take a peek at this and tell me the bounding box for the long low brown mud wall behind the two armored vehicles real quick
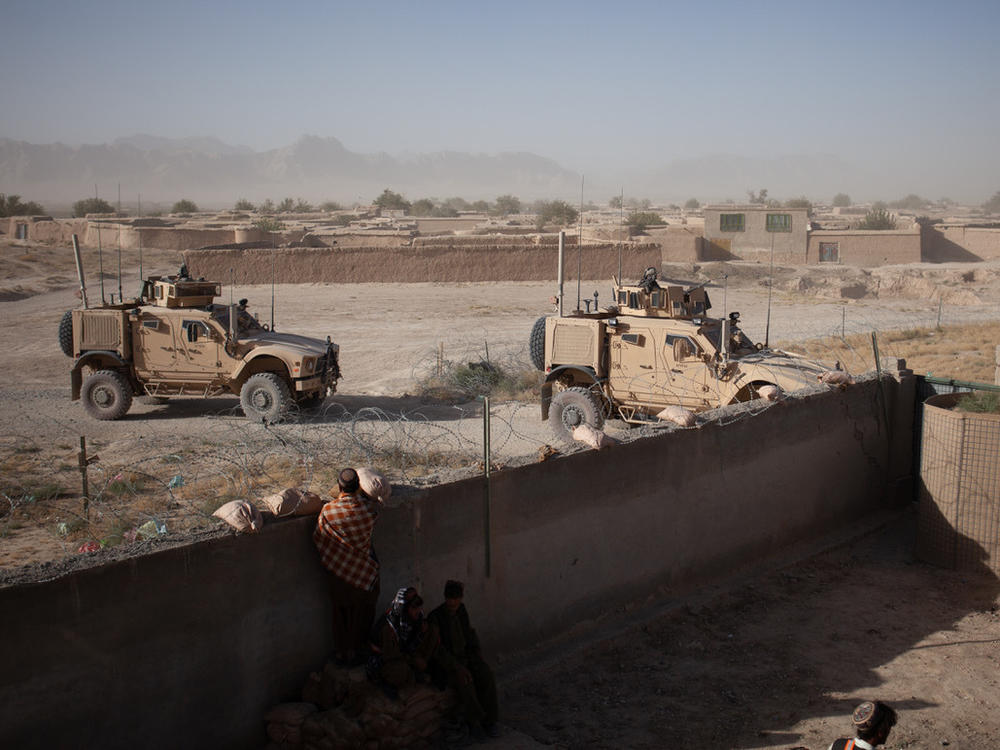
[184,244,660,284]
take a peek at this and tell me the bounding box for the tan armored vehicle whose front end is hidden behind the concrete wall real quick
[529,268,830,440]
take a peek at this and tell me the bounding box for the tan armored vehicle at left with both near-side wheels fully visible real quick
[59,269,340,422]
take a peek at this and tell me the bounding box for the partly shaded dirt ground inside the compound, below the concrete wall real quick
[502,510,1000,750]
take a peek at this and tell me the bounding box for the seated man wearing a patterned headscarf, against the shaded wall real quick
[367,586,438,691]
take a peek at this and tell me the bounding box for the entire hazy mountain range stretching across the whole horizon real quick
[0,135,984,209]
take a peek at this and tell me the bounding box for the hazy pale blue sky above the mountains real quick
[0,0,1000,197]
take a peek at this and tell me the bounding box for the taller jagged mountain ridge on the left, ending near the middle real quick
[0,135,580,205]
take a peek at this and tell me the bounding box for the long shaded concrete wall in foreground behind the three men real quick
[0,378,913,749]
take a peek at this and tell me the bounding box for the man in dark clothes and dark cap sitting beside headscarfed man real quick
[428,581,500,737]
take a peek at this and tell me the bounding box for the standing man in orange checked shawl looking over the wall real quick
[313,469,379,666]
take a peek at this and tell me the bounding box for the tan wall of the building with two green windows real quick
[705,205,809,264]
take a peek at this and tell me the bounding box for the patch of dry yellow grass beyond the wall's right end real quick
[776,321,1000,383]
